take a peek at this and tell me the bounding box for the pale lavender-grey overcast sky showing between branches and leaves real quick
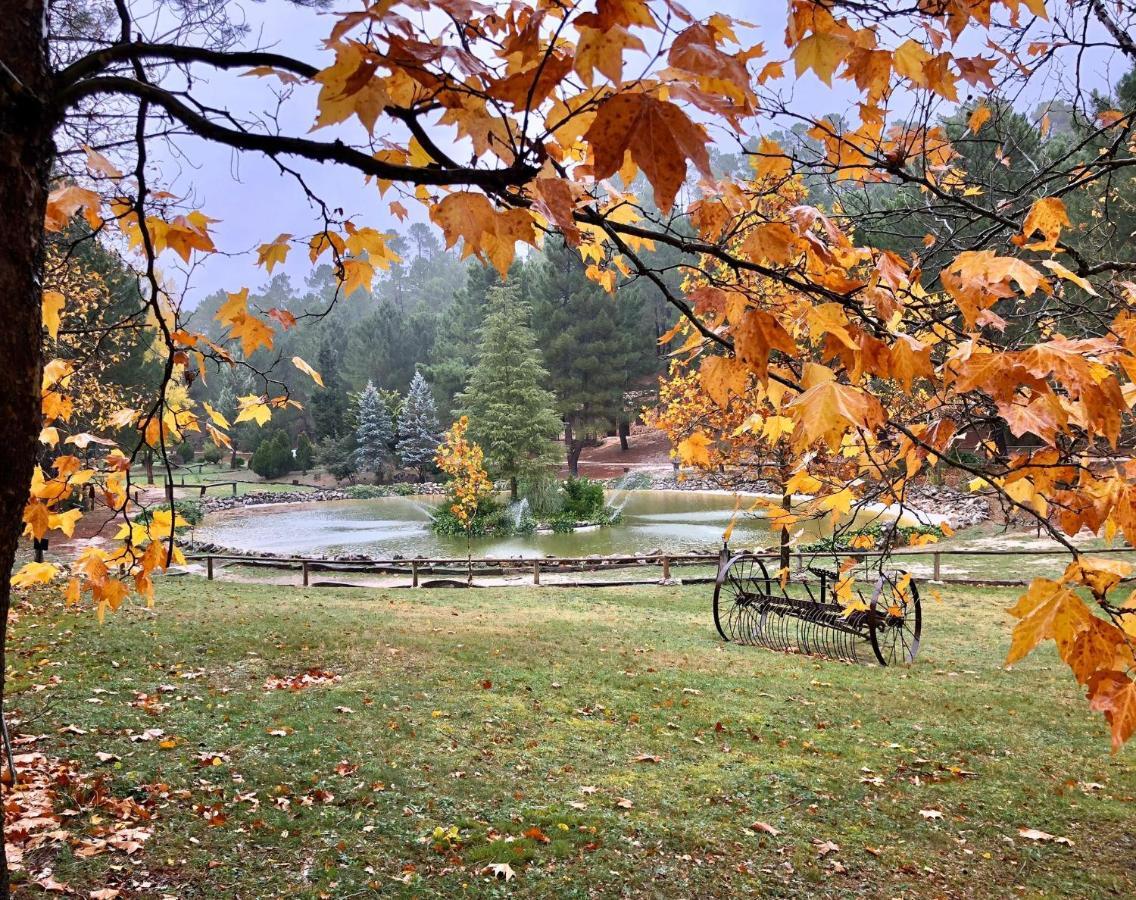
[153,0,1118,307]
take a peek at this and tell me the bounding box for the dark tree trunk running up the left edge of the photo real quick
[0,0,55,898]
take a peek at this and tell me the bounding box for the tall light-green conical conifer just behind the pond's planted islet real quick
[457,286,560,500]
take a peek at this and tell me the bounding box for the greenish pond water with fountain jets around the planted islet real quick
[194,491,836,558]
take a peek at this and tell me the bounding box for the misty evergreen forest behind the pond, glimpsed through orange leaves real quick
[59,74,1136,490]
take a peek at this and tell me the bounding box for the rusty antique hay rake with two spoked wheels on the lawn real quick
[713,547,922,666]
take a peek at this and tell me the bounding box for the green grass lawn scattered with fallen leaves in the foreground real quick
[9,578,1136,898]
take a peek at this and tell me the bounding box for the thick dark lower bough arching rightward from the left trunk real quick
[56,75,537,191]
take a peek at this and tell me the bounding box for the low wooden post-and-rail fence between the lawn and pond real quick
[186,547,1136,588]
